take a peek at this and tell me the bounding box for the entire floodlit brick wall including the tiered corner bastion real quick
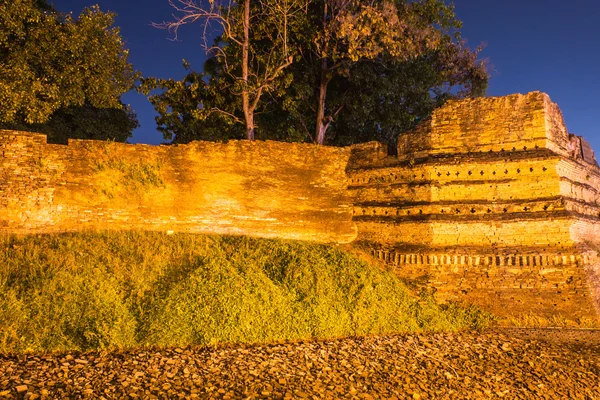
[0,92,600,324]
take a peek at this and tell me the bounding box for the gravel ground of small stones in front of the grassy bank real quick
[0,329,600,399]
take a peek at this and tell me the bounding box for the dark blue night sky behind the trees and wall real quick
[51,0,600,152]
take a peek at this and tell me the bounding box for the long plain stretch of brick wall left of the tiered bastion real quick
[0,131,356,242]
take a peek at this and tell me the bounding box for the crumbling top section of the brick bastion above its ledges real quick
[398,92,569,159]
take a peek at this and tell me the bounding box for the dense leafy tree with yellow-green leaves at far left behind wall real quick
[0,0,138,142]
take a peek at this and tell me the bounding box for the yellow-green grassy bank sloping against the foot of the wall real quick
[0,232,491,353]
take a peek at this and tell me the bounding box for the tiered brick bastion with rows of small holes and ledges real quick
[348,92,600,324]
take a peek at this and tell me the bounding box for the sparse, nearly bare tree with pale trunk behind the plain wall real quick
[153,0,310,140]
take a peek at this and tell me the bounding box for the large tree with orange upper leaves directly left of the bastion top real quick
[282,0,487,144]
